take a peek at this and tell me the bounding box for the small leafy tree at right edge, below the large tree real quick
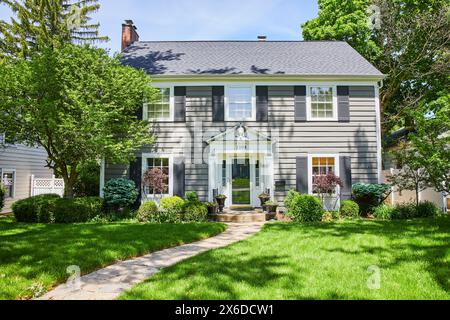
[410,92,450,194]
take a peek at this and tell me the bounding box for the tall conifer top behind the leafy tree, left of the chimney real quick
[0,0,108,58]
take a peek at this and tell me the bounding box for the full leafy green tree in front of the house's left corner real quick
[0,44,154,197]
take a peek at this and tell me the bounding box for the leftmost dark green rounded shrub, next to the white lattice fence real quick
[12,194,60,223]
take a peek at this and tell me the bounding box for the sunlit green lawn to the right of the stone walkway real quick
[121,217,450,300]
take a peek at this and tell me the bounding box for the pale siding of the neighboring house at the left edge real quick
[0,145,53,213]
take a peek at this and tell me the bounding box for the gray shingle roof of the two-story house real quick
[123,41,382,76]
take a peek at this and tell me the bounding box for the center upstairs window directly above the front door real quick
[228,87,253,121]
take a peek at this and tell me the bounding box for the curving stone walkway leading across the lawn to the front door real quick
[39,223,264,300]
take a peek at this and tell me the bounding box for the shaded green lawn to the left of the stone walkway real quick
[0,218,226,299]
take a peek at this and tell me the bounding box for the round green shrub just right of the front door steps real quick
[287,194,325,222]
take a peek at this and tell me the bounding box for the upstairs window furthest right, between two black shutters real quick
[308,86,337,121]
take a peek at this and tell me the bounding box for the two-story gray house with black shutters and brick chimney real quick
[102,20,384,207]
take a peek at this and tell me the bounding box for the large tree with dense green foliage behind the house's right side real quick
[302,0,450,133]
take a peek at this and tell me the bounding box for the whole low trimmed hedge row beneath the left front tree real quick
[12,195,104,223]
